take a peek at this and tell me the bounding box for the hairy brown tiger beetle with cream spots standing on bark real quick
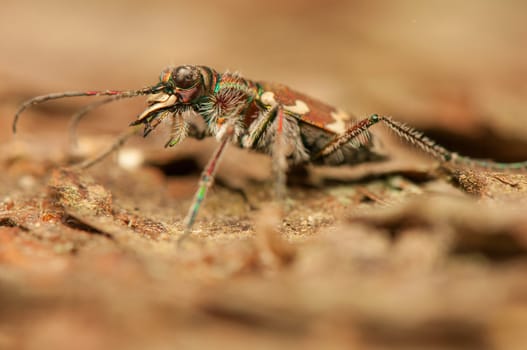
[13,65,527,242]
